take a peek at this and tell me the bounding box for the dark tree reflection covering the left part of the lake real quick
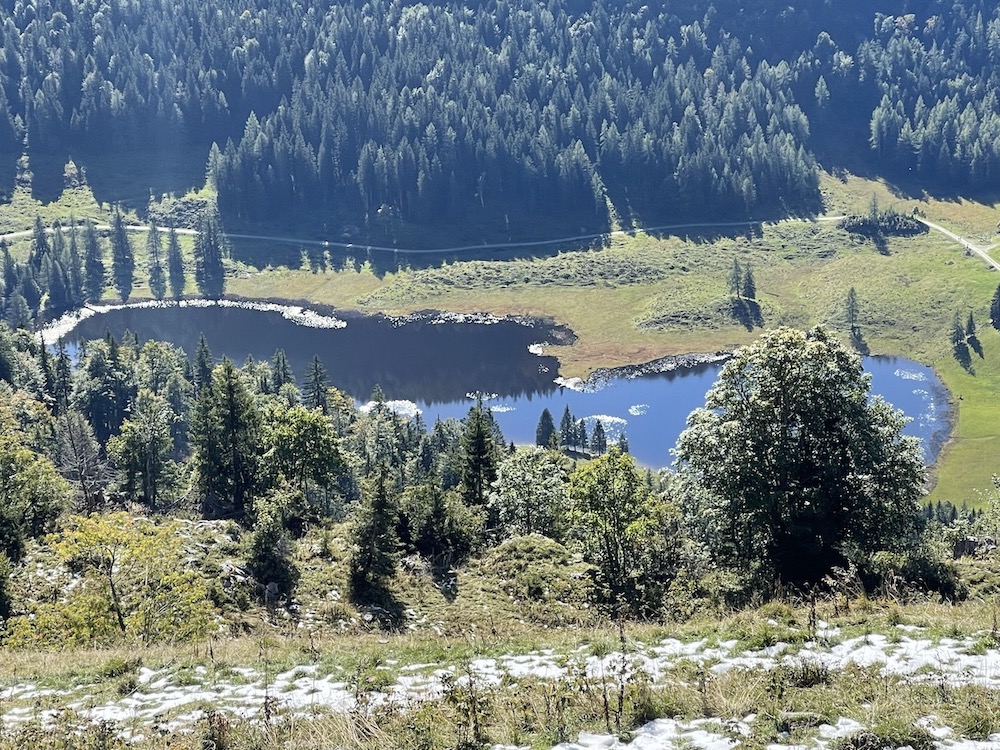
[69,308,559,404]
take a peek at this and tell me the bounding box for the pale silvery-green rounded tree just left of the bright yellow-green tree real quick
[489,446,566,539]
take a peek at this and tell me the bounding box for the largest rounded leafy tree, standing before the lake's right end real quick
[676,328,923,586]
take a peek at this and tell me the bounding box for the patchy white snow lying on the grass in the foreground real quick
[0,624,1000,750]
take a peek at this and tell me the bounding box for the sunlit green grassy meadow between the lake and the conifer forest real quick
[7,170,1000,504]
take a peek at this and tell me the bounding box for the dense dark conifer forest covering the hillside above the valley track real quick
[0,0,1000,232]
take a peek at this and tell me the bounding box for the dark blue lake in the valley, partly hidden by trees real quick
[58,307,949,467]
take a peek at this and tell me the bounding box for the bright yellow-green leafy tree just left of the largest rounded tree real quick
[569,448,677,618]
